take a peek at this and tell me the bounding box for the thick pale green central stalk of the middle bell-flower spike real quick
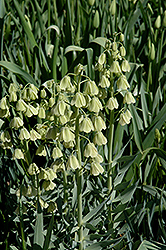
[75,78,83,250]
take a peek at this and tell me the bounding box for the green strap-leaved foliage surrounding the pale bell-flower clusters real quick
[0,0,166,250]
